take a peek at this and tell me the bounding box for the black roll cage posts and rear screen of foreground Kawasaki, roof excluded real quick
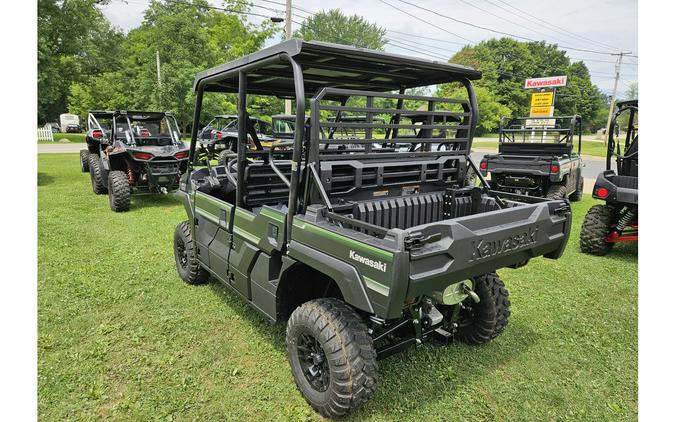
[187,40,480,244]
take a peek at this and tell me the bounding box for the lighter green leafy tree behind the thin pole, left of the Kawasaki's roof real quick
[69,0,276,130]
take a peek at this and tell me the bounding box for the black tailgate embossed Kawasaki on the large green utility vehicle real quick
[407,200,572,297]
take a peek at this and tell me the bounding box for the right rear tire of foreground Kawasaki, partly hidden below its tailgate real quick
[457,273,511,344]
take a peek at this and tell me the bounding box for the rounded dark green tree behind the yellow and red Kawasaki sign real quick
[450,38,603,129]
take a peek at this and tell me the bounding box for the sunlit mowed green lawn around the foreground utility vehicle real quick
[38,154,637,421]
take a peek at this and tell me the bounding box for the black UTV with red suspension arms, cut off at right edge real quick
[580,100,638,255]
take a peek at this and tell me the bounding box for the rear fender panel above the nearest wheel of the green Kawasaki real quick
[288,240,375,314]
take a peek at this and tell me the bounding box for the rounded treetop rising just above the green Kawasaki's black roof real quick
[293,9,387,50]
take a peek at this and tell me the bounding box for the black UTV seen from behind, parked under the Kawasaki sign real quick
[480,116,584,201]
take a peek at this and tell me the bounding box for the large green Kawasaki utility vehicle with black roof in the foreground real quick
[174,40,571,417]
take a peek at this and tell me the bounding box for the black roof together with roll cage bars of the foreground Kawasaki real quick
[188,40,480,244]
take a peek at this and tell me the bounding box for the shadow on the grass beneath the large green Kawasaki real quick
[203,279,537,420]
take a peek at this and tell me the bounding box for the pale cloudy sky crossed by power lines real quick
[101,0,638,98]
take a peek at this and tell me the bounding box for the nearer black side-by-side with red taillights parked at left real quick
[86,111,188,212]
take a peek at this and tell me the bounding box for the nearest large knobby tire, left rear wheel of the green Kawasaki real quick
[286,298,378,418]
